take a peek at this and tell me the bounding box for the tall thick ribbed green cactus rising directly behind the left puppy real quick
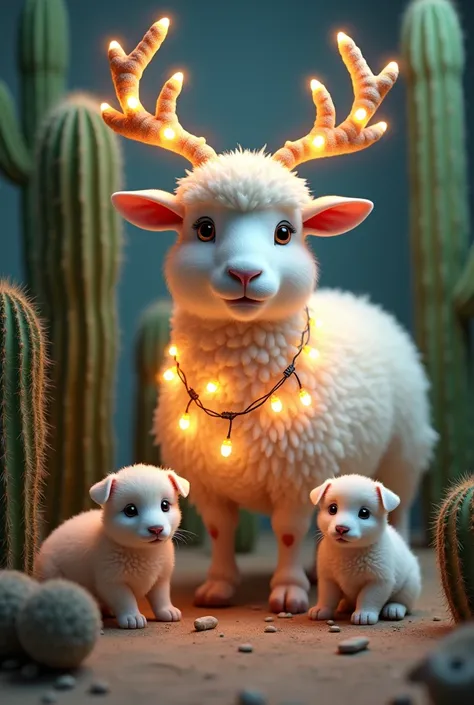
[32,94,122,529]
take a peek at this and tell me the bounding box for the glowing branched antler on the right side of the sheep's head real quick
[273,32,398,169]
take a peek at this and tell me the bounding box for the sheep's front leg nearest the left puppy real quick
[194,497,239,607]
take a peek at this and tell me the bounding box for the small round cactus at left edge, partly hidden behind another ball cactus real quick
[0,570,38,657]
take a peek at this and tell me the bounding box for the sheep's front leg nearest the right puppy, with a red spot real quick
[270,504,312,614]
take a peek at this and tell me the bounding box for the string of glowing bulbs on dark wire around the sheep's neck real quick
[163,307,321,458]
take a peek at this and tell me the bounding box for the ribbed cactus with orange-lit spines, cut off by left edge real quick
[0,281,46,573]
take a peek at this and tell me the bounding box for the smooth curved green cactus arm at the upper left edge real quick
[0,81,31,186]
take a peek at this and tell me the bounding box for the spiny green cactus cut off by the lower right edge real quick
[436,476,474,622]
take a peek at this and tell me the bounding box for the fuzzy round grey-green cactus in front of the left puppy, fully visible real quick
[17,580,102,668]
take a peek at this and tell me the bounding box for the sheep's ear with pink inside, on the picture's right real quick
[303,196,374,237]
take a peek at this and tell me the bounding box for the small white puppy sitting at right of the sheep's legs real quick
[309,475,421,624]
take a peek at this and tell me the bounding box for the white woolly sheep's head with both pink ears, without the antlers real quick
[113,152,372,321]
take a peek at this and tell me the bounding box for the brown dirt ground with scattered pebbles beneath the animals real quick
[0,536,450,705]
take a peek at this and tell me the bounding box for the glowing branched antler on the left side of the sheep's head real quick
[101,17,216,166]
